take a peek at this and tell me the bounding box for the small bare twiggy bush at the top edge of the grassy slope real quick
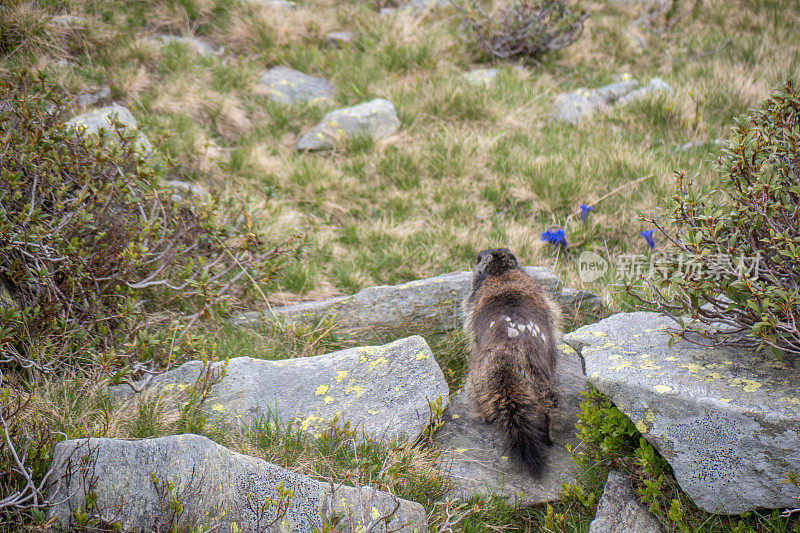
[456,0,589,59]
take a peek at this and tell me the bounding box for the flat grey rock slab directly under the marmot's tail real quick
[436,340,587,505]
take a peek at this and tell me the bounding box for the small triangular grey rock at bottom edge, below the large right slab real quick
[589,471,664,533]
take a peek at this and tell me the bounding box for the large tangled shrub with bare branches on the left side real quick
[0,71,296,378]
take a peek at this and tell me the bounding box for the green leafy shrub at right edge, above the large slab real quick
[640,81,800,355]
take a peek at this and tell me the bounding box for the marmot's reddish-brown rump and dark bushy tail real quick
[475,346,554,476]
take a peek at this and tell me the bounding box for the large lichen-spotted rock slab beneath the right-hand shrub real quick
[564,312,800,514]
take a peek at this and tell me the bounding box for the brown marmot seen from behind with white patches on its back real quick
[463,248,561,476]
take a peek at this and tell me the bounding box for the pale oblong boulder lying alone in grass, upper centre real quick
[297,98,400,150]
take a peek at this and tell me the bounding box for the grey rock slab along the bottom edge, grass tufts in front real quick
[49,435,427,533]
